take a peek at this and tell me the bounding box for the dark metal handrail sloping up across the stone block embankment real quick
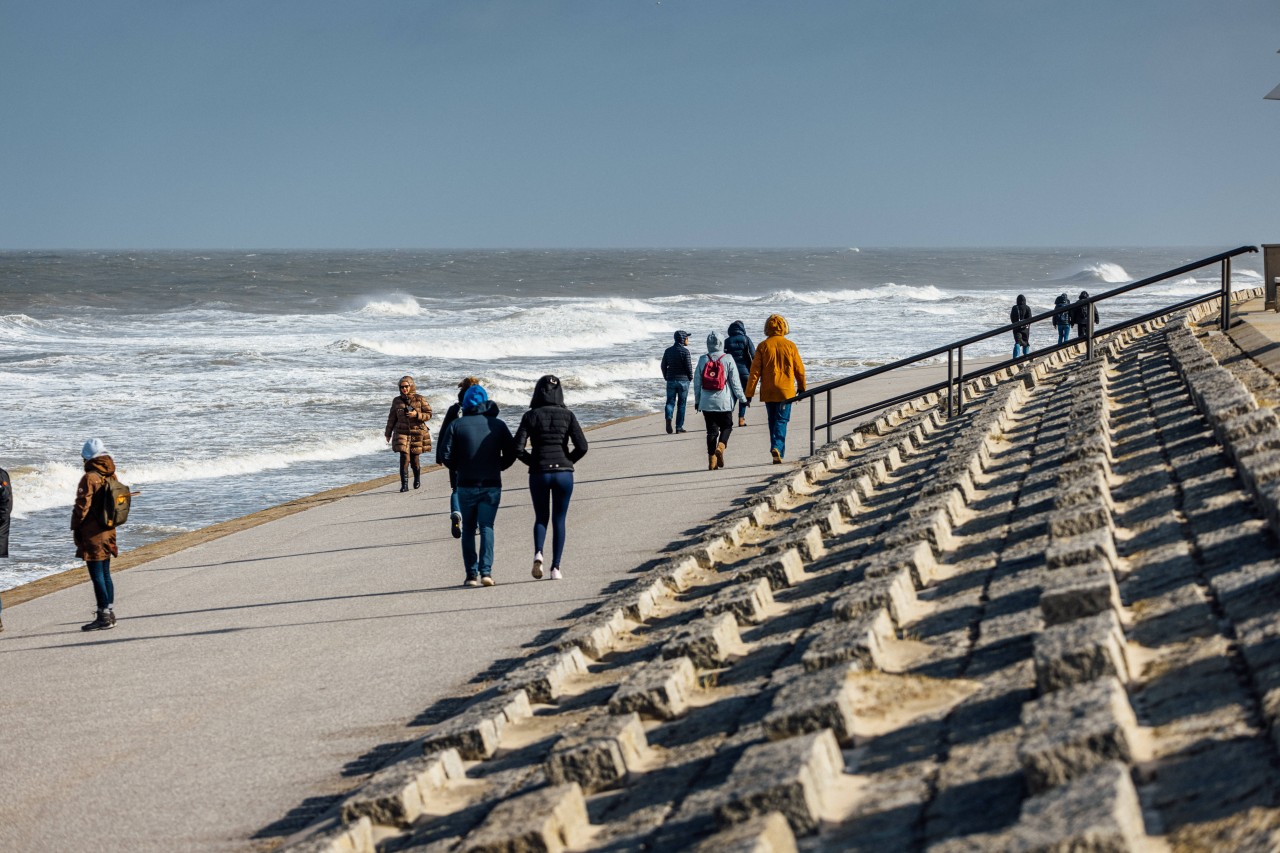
[785,246,1258,455]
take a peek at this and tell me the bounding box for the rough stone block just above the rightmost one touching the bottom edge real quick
[1018,678,1138,793]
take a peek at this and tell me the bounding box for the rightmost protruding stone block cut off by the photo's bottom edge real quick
[1011,762,1148,853]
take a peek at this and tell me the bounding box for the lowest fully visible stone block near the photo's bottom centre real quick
[717,730,845,835]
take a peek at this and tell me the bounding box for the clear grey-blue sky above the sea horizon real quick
[0,0,1280,248]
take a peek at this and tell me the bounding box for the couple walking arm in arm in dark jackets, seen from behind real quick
[436,375,588,587]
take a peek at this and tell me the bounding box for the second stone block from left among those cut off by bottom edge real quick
[461,783,589,853]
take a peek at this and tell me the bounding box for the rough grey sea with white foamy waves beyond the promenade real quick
[0,247,1261,589]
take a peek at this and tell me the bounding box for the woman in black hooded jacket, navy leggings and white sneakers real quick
[516,375,588,580]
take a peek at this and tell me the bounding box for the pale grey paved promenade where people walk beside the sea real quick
[0,369,967,852]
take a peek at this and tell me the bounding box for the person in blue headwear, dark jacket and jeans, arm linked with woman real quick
[440,384,516,587]
